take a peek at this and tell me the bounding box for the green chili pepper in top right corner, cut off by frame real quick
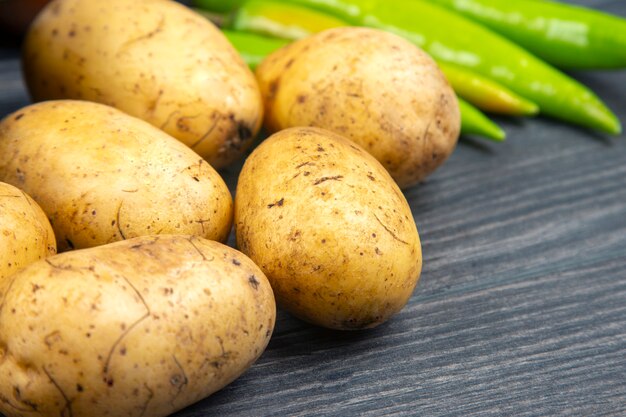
[431,0,626,68]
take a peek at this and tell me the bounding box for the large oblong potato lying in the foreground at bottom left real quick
[0,235,276,417]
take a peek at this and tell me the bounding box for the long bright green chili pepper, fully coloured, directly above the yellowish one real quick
[278,0,621,134]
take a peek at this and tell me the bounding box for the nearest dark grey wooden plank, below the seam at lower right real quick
[177,255,626,416]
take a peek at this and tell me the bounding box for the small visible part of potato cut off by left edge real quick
[0,182,57,282]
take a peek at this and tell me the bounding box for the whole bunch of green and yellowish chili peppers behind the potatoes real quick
[196,0,626,140]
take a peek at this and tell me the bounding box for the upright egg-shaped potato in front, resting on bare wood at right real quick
[235,128,421,329]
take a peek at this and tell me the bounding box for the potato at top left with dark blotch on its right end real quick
[23,0,263,169]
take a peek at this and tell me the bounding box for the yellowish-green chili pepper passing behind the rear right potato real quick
[227,0,539,116]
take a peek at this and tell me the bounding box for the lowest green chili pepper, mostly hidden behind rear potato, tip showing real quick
[222,29,505,142]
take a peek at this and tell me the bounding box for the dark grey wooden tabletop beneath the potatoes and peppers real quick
[0,0,626,417]
